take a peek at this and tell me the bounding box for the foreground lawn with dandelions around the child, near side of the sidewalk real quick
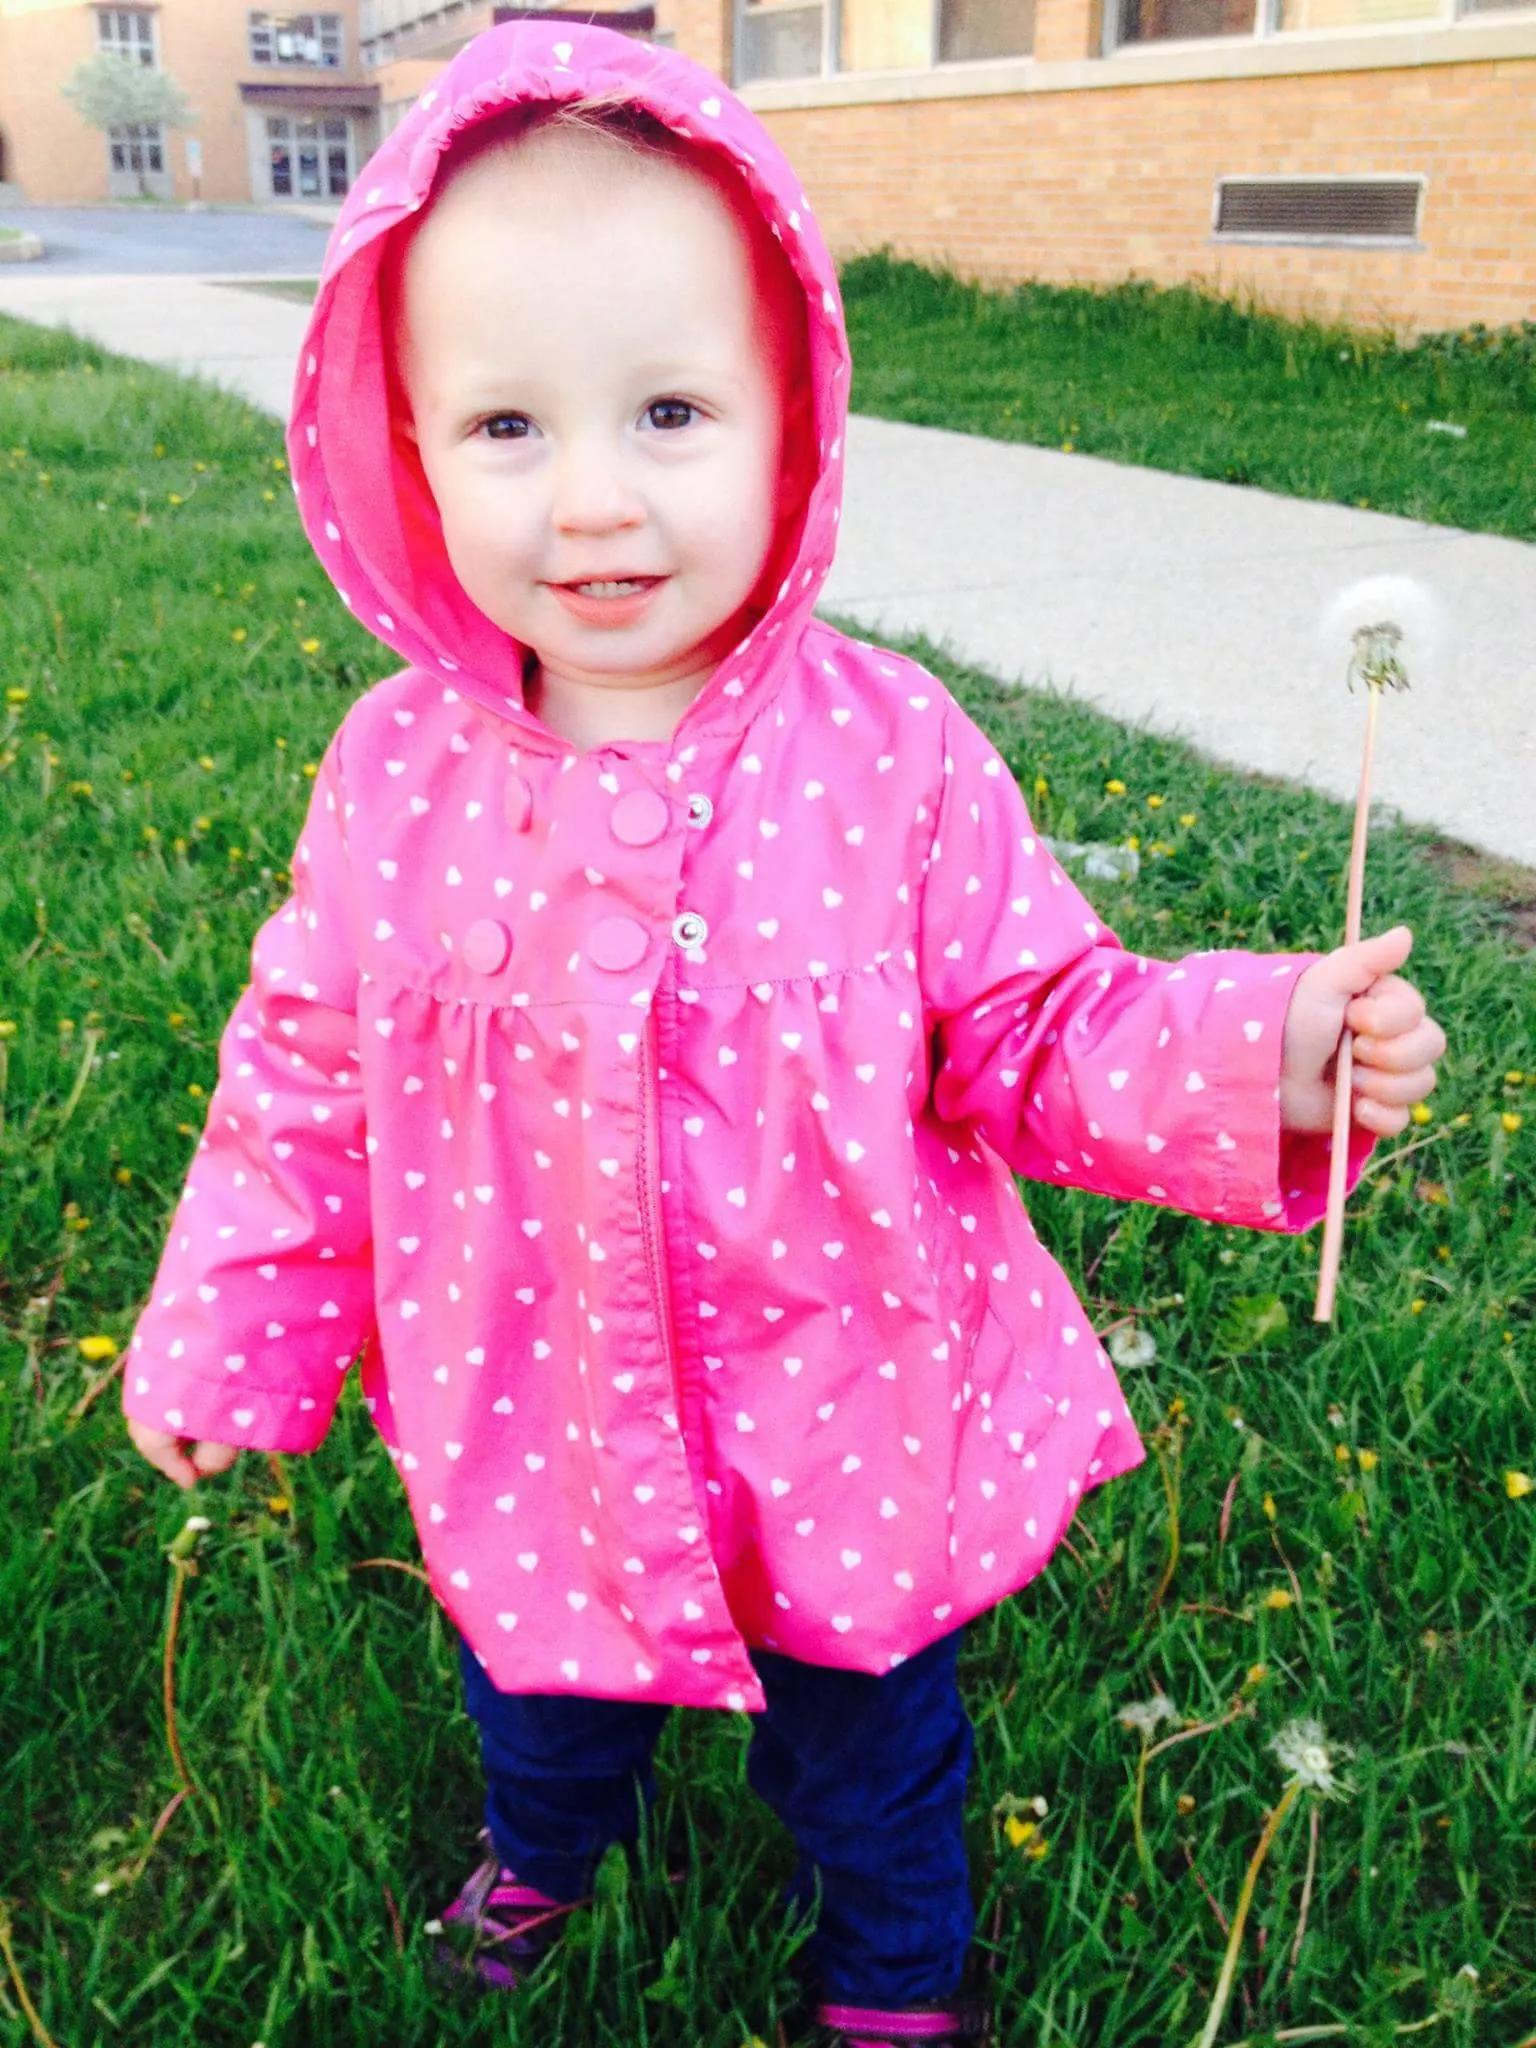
[0,307,1536,2048]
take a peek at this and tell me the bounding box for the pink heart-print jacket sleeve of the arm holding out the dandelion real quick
[920,705,1372,1231]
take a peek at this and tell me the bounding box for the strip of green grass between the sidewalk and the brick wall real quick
[842,256,1536,541]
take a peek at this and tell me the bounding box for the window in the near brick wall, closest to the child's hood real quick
[735,0,1036,84]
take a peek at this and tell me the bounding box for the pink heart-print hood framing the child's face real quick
[289,20,848,743]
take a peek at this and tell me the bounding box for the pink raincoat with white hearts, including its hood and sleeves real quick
[125,23,1368,1708]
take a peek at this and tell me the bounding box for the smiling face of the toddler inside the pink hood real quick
[397,131,798,729]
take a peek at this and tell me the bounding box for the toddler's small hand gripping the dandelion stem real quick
[1280,924,1446,1137]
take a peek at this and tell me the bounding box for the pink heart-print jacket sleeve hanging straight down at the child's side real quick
[123,733,373,1450]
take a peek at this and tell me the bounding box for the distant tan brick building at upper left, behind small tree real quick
[0,0,379,205]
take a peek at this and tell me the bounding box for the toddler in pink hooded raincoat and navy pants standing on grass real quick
[125,20,1444,2044]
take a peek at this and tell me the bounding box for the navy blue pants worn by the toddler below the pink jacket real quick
[461,1630,975,2011]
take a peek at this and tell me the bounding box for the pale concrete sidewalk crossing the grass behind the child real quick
[0,266,1536,866]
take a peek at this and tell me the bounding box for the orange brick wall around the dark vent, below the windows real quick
[764,59,1536,332]
